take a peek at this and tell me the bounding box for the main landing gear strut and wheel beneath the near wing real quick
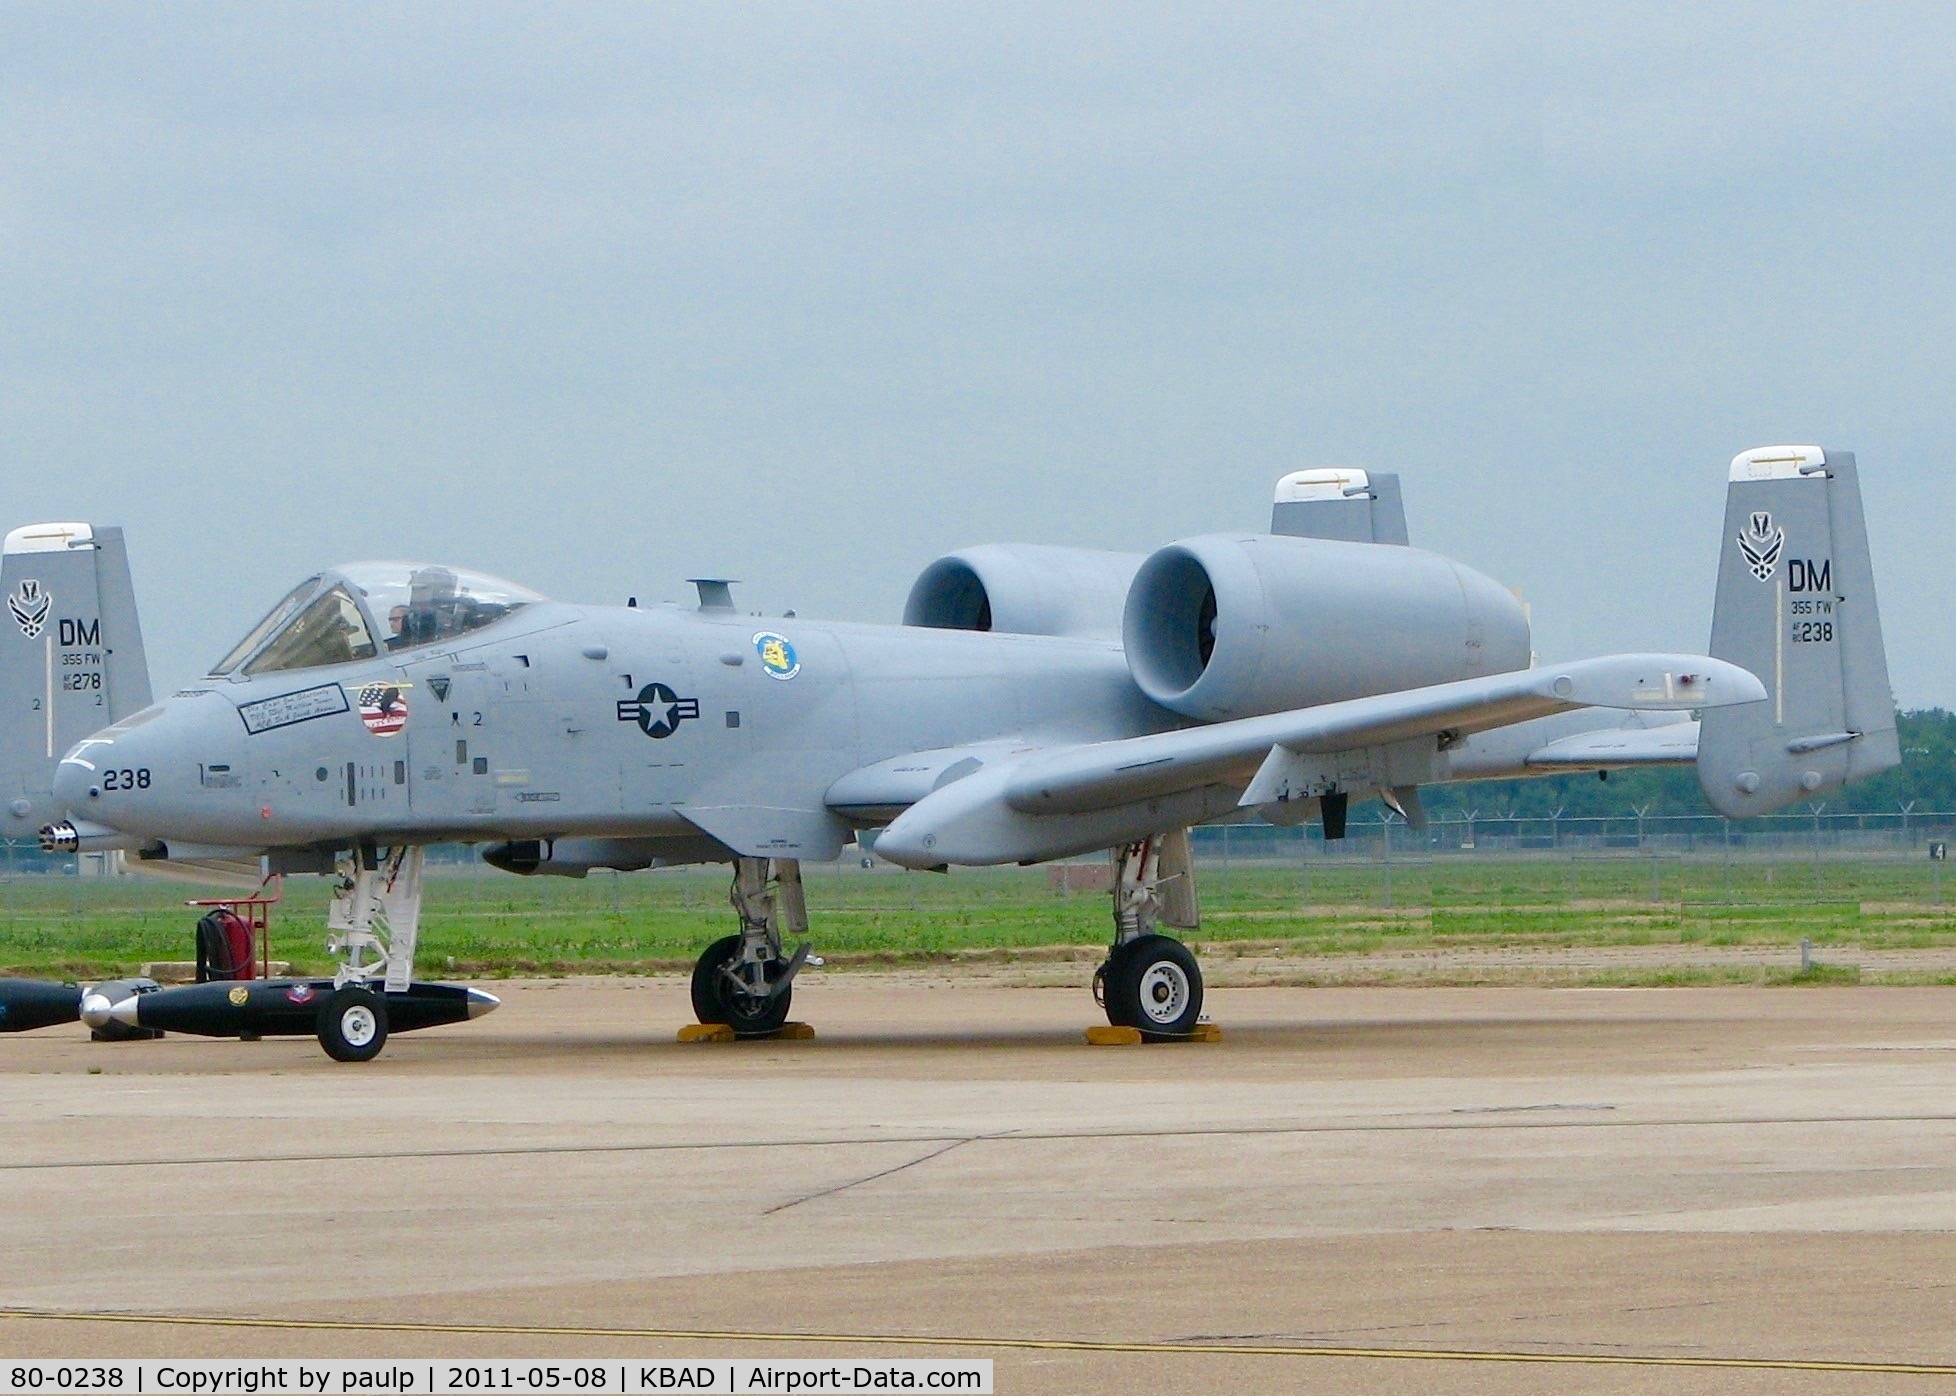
[1093,829,1203,1042]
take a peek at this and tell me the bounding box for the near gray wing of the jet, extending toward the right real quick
[864,655,1766,868]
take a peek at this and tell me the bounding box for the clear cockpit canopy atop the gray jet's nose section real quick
[211,563,544,676]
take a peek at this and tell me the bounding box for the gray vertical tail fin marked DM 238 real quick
[1698,446,1901,817]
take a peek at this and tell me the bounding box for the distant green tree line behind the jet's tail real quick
[1455,708,1956,819]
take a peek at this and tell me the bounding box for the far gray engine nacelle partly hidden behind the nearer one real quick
[904,544,1142,639]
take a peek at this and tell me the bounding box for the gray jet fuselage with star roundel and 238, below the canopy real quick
[57,586,1181,858]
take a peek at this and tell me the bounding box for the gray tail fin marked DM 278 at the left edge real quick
[0,524,149,839]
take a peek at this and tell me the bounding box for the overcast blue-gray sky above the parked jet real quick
[0,0,1956,706]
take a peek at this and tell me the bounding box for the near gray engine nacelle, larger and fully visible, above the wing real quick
[1121,534,1528,721]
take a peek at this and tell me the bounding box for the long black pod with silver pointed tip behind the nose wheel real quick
[113,980,499,1038]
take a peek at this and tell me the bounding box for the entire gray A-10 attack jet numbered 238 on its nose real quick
[16,446,1899,1060]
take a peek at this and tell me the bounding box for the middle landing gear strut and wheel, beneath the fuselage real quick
[692,858,808,1038]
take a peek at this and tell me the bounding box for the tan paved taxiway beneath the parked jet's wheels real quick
[0,974,1956,1392]
